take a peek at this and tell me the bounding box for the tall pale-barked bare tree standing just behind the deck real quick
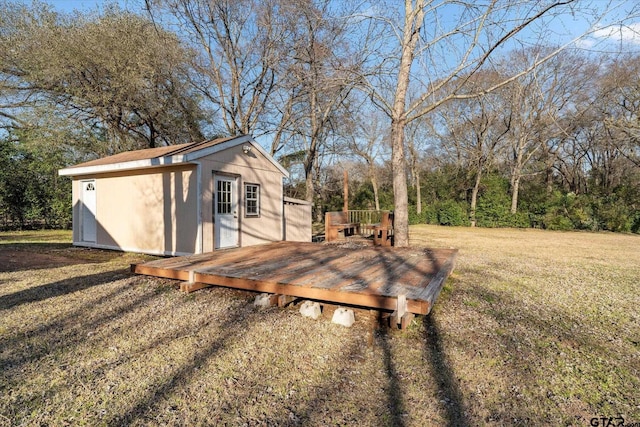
[358,0,632,246]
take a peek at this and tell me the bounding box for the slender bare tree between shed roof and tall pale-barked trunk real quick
[274,0,359,201]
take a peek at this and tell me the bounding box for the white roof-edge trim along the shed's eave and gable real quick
[58,135,289,178]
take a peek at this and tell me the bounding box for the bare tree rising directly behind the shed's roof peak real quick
[146,0,288,135]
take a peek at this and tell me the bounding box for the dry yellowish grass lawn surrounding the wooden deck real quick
[0,226,640,426]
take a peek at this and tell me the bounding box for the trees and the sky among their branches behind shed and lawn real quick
[0,0,640,237]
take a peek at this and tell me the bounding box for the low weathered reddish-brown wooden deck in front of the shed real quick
[131,242,457,316]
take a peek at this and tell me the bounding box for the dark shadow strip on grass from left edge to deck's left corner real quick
[0,269,129,311]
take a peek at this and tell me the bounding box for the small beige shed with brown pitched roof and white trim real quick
[59,135,311,255]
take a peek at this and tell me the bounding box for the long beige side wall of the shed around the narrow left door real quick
[73,165,198,254]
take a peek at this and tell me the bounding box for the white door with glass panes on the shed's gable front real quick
[213,175,239,249]
